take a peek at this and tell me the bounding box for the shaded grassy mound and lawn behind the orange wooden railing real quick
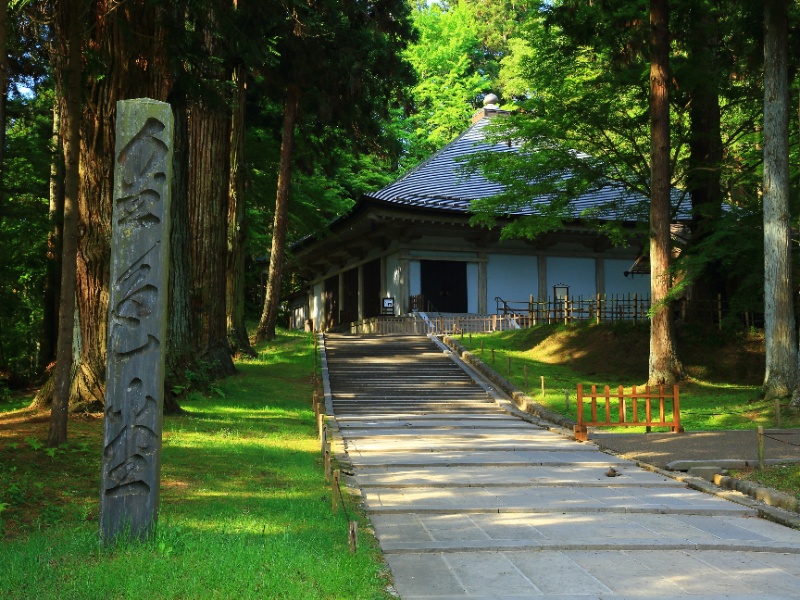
[456,324,800,433]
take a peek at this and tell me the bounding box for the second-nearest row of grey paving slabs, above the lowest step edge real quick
[372,513,800,561]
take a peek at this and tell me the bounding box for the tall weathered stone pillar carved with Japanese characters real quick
[100,98,173,544]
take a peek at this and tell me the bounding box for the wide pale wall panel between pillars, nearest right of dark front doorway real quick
[486,254,539,312]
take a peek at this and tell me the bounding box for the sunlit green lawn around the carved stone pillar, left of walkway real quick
[0,334,389,599]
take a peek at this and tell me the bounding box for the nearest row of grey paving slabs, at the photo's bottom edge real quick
[386,549,800,600]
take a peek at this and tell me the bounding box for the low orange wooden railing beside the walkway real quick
[575,383,683,442]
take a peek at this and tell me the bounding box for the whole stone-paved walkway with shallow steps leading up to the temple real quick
[326,335,800,600]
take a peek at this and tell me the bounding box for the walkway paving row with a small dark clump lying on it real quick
[355,464,686,489]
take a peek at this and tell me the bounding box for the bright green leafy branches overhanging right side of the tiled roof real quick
[471,5,687,241]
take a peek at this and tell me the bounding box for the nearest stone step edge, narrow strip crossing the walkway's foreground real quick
[380,540,800,554]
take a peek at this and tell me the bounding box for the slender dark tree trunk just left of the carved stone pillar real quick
[47,0,83,447]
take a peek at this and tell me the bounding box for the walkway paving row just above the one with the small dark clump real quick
[348,449,630,468]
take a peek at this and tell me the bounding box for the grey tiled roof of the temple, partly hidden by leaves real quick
[367,111,686,221]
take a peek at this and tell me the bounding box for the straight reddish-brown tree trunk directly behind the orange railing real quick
[648,0,681,385]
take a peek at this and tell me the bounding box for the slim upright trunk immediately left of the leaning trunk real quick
[225,64,255,356]
